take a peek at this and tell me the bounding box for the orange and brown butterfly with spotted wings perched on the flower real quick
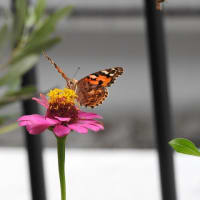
[43,52,124,108]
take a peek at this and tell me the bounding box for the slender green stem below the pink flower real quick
[57,136,67,200]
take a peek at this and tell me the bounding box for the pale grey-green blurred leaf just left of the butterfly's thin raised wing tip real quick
[0,55,38,86]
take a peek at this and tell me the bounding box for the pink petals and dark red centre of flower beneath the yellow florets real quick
[17,90,104,137]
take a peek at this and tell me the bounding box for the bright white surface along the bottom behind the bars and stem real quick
[0,148,200,200]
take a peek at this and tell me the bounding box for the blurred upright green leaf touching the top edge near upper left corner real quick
[13,0,27,45]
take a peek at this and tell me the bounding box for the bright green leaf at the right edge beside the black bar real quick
[169,138,200,156]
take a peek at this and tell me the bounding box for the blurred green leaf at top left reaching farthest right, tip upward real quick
[27,6,72,48]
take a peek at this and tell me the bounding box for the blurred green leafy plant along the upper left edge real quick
[0,0,72,134]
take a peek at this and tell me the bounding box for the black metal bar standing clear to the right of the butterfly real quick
[145,0,176,200]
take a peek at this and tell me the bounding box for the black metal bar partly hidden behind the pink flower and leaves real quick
[11,0,46,200]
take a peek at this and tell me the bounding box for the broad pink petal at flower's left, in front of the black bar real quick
[17,114,59,135]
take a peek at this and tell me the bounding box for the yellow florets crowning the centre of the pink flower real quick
[47,88,77,106]
